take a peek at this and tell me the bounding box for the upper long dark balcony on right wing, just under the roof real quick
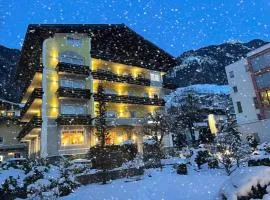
[91,70,150,86]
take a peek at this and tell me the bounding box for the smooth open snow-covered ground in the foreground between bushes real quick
[61,166,228,200]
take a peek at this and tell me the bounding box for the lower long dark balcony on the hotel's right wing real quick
[94,94,165,106]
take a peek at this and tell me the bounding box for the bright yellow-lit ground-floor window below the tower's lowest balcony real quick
[61,129,85,146]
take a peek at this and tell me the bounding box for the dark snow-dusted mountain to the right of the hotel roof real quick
[164,39,267,87]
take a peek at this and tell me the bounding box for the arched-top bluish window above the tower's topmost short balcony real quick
[59,51,85,65]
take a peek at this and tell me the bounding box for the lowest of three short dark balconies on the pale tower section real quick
[56,114,93,126]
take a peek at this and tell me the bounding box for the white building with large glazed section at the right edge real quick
[226,44,270,141]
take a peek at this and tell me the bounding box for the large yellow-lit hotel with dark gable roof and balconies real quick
[17,24,175,157]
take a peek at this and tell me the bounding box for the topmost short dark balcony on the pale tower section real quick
[56,62,90,76]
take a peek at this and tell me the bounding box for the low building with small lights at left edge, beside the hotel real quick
[0,100,27,161]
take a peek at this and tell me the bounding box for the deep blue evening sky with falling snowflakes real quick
[0,0,270,56]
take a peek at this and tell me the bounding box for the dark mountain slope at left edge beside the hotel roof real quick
[0,45,22,102]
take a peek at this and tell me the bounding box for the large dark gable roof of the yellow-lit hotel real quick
[17,24,176,79]
